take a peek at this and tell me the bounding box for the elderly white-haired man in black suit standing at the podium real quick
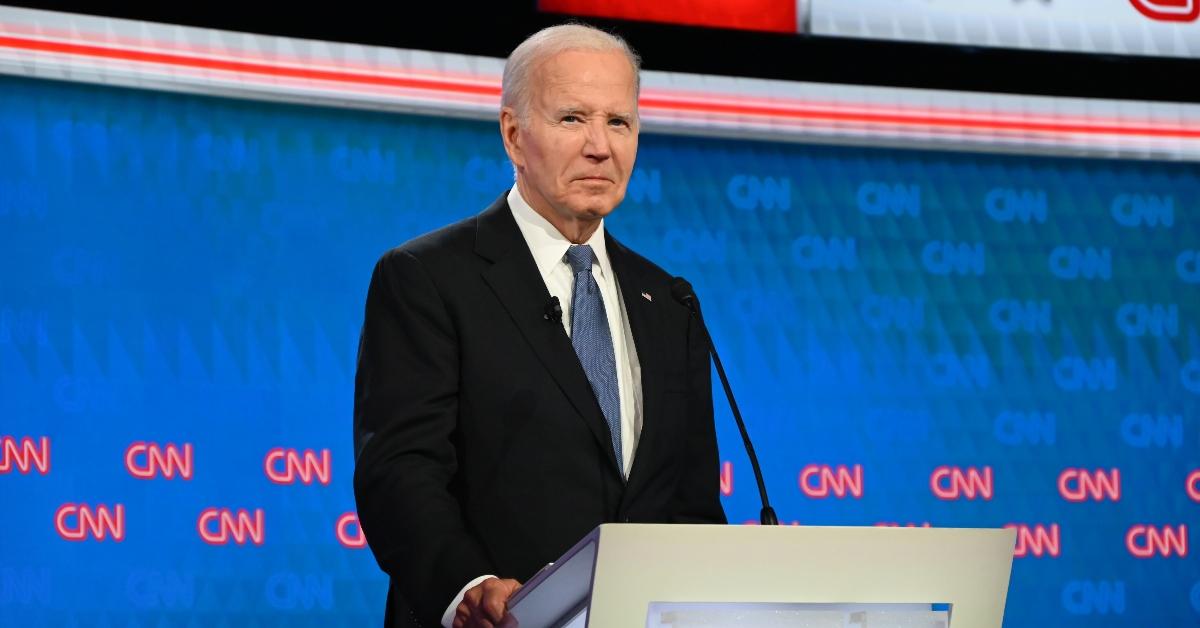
[354,25,725,627]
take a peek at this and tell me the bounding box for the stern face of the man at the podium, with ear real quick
[500,50,637,231]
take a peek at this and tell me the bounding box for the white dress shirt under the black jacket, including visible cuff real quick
[442,185,642,628]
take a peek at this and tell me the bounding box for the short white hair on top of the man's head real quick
[500,24,642,125]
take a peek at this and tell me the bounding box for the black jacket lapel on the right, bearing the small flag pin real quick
[605,229,668,501]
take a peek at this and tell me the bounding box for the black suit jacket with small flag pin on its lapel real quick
[354,197,725,626]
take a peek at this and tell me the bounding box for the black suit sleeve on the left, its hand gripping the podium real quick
[354,250,494,626]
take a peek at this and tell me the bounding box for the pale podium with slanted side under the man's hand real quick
[509,524,1016,628]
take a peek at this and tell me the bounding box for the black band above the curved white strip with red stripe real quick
[8,0,1200,102]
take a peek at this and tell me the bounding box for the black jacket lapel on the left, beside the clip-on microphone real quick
[475,197,618,471]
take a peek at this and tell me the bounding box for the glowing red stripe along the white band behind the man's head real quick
[0,35,1200,139]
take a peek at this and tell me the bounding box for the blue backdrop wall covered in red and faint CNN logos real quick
[0,78,1200,627]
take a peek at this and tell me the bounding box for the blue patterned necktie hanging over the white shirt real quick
[566,244,624,474]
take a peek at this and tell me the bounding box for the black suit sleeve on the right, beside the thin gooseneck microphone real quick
[671,309,726,524]
